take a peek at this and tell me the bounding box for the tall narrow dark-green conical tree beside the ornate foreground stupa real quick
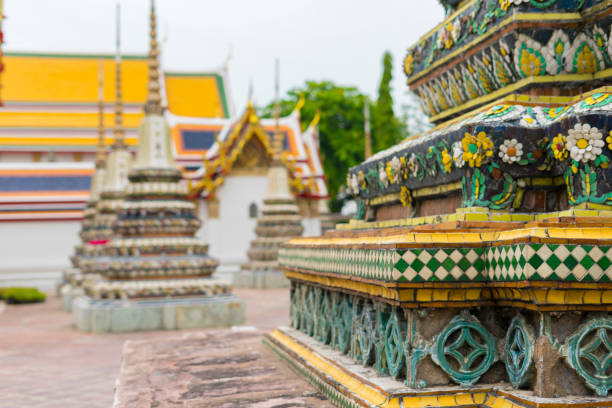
[372,51,406,152]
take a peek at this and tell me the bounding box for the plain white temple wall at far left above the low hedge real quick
[0,221,80,289]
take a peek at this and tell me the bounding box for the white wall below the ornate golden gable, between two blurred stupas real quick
[198,175,268,273]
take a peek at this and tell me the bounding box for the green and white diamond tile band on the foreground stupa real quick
[279,244,612,282]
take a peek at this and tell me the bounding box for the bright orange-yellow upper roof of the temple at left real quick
[0,52,231,116]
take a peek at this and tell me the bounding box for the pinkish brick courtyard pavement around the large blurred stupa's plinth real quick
[0,289,289,408]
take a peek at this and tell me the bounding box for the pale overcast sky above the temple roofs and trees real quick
[3,0,444,111]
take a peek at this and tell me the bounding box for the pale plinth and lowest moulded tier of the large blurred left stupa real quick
[72,277,245,333]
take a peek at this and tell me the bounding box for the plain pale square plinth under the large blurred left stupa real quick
[72,295,245,333]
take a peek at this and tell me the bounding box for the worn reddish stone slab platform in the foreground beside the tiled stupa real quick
[114,328,332,408]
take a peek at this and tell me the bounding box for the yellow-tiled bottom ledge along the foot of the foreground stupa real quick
[264,327,612,408]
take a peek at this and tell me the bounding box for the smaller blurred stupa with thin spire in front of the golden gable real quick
[234,79,304,289]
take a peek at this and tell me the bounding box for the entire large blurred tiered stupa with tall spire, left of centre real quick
[74,2,244,331]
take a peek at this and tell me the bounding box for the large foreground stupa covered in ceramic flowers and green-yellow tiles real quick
[266,0,612,408]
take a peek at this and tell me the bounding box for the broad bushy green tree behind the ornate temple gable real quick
[261,81,365,211]
